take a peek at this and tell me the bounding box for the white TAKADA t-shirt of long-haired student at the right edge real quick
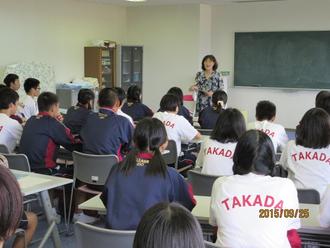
[280,140,330,197]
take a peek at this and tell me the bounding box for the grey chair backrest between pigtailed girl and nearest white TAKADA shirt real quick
[188,170,219,196]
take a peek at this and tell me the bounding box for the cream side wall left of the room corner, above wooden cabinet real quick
[0,0,126,82]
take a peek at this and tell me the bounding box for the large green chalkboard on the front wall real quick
[234,31,330,89]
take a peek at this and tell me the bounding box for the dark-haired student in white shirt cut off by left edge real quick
[0,87,23,152]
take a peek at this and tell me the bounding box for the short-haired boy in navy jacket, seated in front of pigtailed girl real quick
[80,88,133,160]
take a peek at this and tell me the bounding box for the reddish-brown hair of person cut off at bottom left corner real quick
[0,166,23,241]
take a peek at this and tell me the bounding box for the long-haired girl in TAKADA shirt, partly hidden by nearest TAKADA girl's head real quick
[196,108,246,176]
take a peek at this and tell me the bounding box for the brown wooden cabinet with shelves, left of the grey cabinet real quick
[84,47,116,89]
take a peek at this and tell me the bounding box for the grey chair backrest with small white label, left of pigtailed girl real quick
[72,151,118,185]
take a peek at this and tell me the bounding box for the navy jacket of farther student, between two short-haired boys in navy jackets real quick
[63,104,92,134]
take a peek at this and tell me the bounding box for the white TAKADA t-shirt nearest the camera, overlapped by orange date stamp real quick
[209,173,300,248]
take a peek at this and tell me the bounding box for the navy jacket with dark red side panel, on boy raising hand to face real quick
[19,112,75,170]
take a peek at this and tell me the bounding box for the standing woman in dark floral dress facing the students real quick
[191,55,224,113]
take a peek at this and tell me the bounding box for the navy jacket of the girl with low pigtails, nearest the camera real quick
[101,154,196,230]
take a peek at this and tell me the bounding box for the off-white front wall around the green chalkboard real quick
[212,0,330,128]
